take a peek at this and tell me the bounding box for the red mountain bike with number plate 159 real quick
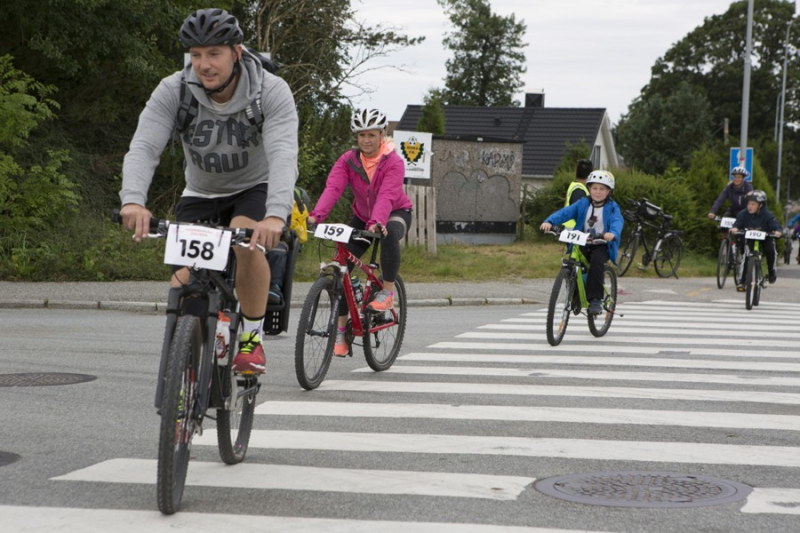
[295,224,406,390]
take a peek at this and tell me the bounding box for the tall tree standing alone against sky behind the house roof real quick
[437,0,526,106]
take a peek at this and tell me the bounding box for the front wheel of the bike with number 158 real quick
[156,315,203,514]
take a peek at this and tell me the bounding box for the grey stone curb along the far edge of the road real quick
[0,298,542,313]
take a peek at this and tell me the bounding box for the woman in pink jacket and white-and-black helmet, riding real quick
[308,109,412,357]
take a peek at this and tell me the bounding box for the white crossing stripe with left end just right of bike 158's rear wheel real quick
[256,401,800,431]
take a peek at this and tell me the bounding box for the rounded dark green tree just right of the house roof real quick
[615,81,712,174]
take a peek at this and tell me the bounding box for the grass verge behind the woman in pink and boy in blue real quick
[295,237,717,283]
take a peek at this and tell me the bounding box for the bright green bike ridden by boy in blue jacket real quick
[546,226,622,346]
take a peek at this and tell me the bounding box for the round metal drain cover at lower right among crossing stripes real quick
[536,472,753,508]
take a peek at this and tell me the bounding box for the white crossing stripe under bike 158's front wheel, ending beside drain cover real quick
[52,460,535,500]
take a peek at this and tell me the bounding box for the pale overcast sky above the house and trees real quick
[344,0,752,123]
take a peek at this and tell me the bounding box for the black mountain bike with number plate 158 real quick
[112,211,298,514]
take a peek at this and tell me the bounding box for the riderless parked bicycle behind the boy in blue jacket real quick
[619,198,683,279]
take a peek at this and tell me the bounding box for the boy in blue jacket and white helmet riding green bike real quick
[539,170,625,315]
